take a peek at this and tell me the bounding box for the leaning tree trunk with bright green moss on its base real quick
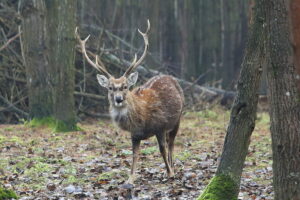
[199,0,265,200]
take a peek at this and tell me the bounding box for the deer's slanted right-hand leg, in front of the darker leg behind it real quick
[156,132,174,177]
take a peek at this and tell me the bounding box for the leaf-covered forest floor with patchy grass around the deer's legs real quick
[0,108,273,200]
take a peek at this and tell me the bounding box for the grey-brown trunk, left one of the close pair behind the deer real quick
[19,0,53,119]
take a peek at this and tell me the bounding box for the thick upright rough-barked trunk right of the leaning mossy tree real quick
[266,0,300,200]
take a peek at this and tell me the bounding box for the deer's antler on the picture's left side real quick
[75,27,111,77]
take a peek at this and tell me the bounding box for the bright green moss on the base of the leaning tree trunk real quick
[198,174,238,200]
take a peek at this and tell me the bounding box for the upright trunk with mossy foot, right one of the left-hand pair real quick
[46,0,76,131]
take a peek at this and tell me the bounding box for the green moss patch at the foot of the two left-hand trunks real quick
[25,117,82,132]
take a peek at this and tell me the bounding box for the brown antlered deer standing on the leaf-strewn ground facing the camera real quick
[75,20,184,184]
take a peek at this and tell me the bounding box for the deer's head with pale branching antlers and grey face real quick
[75,20,150,108]
